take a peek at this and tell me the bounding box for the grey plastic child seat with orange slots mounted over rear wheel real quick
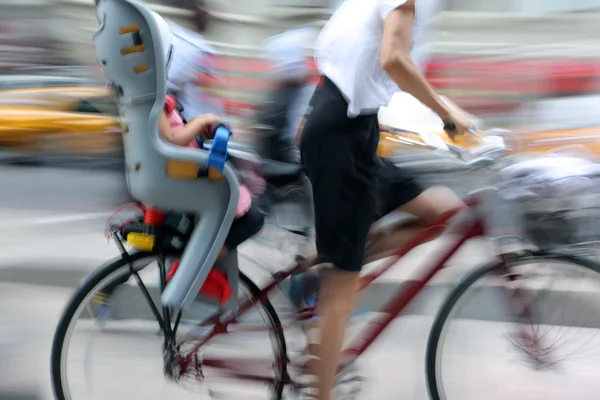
[94,0,239,310]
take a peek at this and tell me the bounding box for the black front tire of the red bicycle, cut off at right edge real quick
[425,250,600,400]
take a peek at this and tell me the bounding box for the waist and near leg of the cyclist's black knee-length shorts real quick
[300,78,380,271]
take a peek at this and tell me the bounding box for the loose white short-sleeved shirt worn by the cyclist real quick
[315,0,440,117]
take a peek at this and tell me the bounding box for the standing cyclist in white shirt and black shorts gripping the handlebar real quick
[300,0,471,400]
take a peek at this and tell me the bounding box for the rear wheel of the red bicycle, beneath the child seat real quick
[52,254,287,400]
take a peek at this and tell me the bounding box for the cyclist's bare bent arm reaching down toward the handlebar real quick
[380,0,452,121]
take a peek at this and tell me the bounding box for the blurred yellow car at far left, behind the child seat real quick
[0,76,120,158]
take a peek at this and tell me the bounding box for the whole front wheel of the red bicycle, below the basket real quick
[426,252,600,400]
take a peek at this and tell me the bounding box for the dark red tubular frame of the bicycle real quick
[181,196,484,384]
